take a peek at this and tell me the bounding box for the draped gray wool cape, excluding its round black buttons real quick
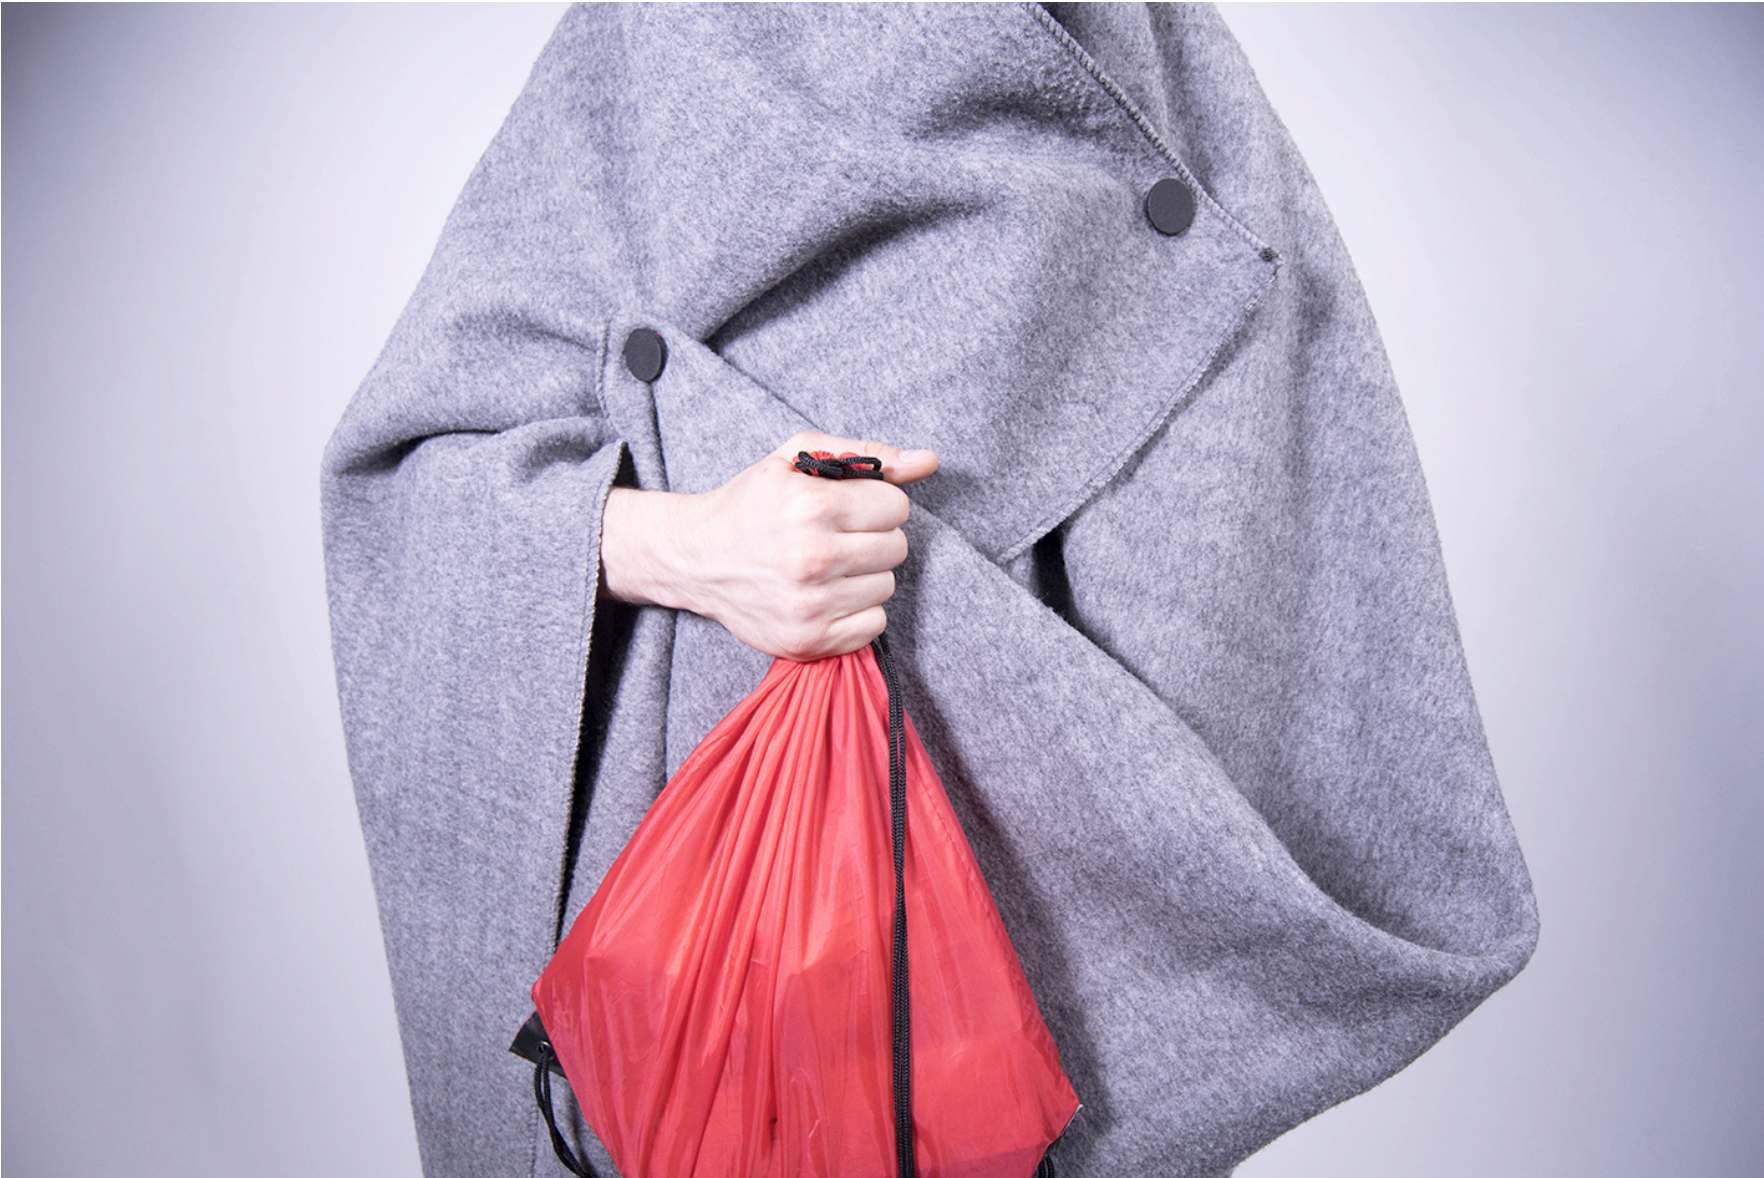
[323,5,1536,1178]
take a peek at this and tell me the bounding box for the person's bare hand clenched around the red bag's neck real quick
[600,432,937,661]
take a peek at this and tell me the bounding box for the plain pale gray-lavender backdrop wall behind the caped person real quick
[4,5,1764,1178]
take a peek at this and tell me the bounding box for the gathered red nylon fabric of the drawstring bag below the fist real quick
[533,647,1078,1178]
